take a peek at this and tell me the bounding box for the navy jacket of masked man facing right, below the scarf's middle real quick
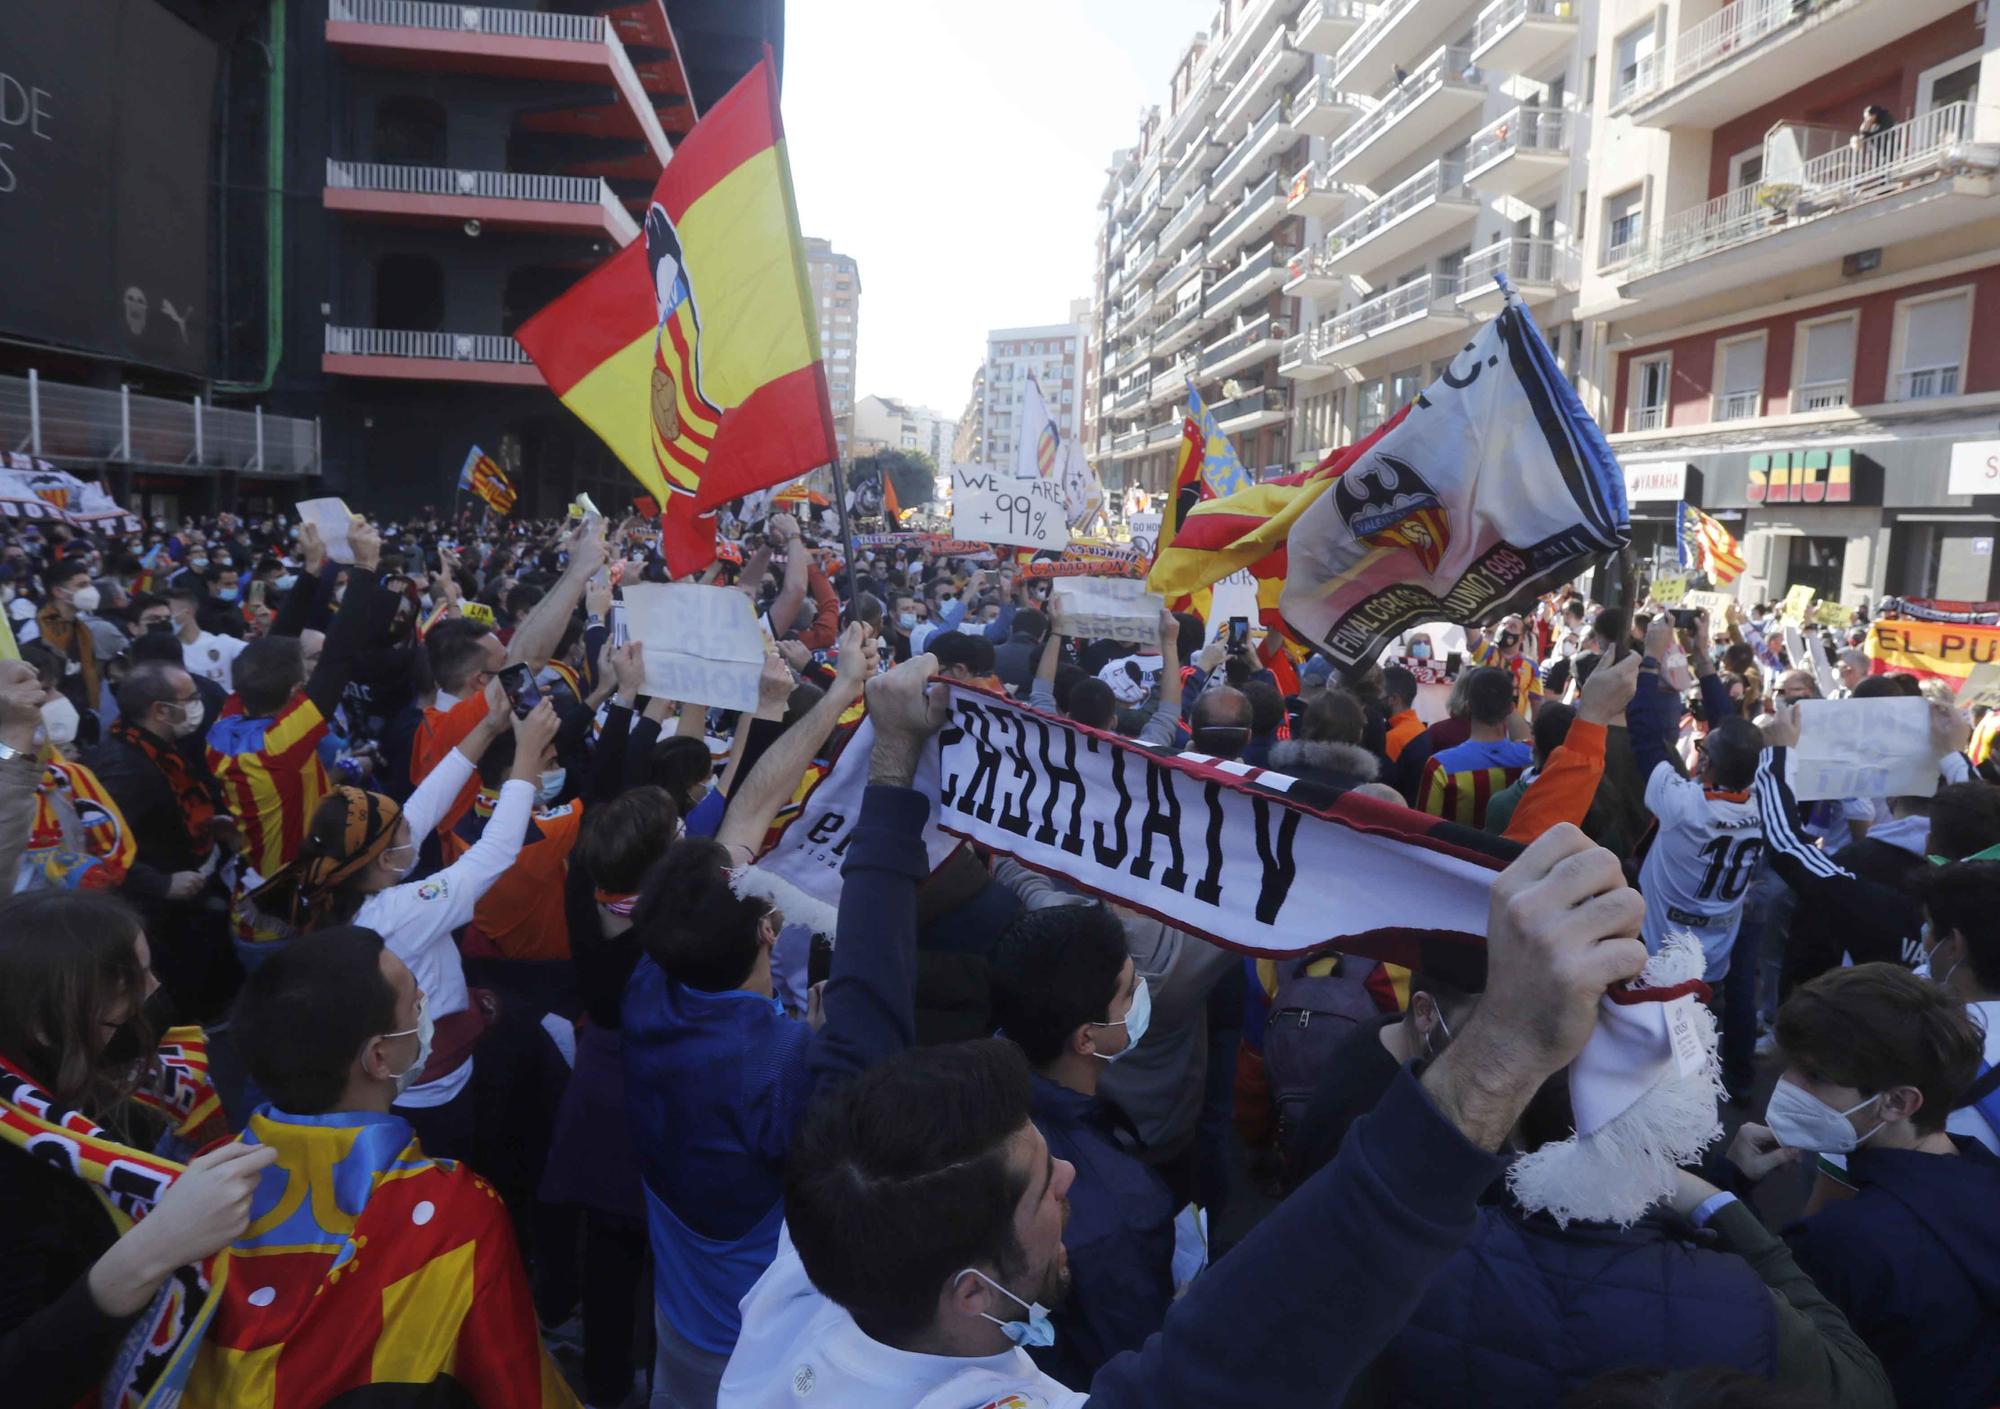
[1032,1075,1174,1389]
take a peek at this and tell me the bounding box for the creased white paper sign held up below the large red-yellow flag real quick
[624,582,764,711]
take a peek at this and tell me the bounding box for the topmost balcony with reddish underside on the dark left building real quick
[326,0,674,164]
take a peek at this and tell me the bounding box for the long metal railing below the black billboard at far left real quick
[0,376,320,476]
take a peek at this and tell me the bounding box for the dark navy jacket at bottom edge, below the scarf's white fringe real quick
[1376,1205,1778,1409]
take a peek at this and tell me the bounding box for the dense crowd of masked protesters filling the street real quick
[0,498,2000,1409]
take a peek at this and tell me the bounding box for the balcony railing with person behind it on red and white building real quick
[1632,102,1972,278]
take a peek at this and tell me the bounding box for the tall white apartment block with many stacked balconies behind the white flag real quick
[1096,0,1598,500]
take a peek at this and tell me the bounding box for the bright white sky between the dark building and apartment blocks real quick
[784,0,1216,416]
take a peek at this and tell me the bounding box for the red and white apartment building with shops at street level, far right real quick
[1582,0,2000,604]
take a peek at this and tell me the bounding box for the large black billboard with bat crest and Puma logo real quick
[0,0,216,374]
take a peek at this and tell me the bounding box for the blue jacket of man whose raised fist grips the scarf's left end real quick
[622,787,930,1355]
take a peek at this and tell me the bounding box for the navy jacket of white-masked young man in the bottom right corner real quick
[1784,1137,2000,1409]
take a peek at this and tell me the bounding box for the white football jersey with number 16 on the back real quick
[1638,763,1764,981]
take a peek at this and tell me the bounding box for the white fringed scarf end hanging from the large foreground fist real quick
[1508,931,1722,1227]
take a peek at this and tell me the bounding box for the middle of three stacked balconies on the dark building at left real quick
[320,160,638,244]
